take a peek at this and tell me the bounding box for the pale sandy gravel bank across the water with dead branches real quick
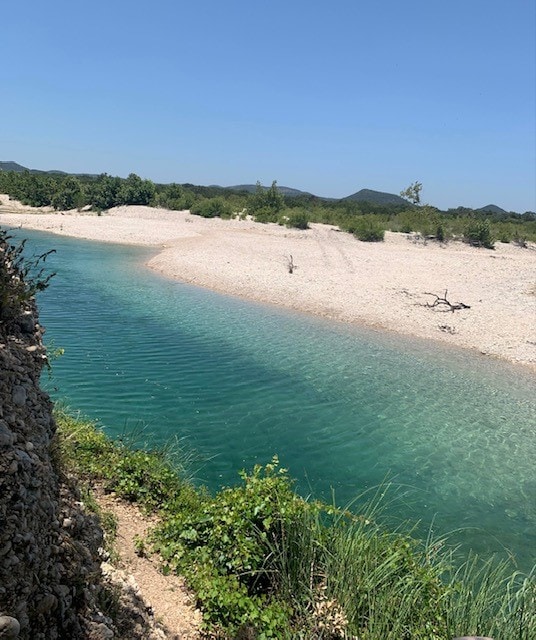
[0,196,536,371]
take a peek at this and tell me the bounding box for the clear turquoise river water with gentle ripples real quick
[12,232,536,569]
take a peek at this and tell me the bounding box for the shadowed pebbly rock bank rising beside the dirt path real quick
[0,238,109,640]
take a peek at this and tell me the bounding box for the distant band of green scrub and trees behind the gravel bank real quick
[0,171,536,249]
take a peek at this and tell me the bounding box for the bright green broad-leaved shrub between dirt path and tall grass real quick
[153,458,304,638]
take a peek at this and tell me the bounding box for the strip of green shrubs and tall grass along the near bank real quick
[57,413,536,640]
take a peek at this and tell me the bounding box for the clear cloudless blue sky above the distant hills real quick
[0,0,536,212]
